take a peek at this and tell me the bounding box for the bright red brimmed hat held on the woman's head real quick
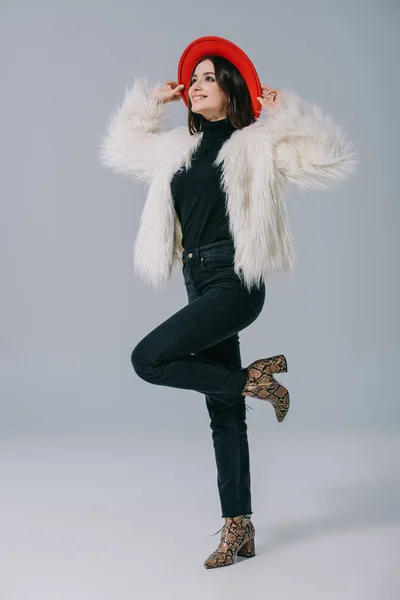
[178,35,262,118]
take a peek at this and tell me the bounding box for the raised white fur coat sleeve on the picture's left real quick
[99,78,170,183]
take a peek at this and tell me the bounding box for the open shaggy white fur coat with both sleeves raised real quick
[100,78,357,290]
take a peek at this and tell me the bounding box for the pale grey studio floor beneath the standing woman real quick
[0,426,400,600]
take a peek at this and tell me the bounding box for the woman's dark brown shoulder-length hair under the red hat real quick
[188,56,256,135]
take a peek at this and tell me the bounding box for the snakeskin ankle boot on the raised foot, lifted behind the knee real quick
[242,354,290,422]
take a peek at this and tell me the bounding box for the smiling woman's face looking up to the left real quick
[188,59,228,121]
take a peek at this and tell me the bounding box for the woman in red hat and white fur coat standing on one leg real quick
[102,36,355,568]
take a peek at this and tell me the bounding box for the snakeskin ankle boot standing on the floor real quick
[204,515,255,569]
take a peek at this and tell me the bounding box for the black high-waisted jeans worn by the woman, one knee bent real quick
[131,240,265,517]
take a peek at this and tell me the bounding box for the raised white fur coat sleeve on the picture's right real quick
[266,90,357,189]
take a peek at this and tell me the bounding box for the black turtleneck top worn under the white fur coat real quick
[171,118,235,250]
